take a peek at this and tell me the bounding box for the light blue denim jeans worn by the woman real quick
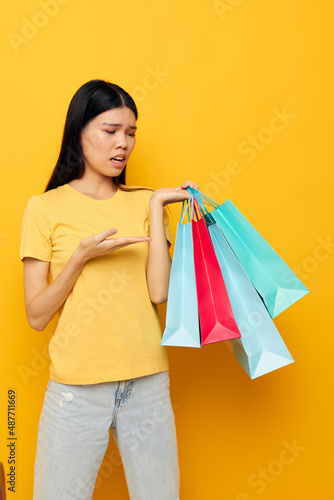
[34,371,179,500]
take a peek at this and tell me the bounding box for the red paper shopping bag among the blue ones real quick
[191,200,241,345]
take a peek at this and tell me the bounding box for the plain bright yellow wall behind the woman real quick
[0,0,334,500]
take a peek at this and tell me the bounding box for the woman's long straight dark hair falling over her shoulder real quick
[45,80,145,192]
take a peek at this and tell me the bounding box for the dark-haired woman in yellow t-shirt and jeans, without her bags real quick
[20,80,198,500]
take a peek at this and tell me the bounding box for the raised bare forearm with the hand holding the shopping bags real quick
[146,181,198,304]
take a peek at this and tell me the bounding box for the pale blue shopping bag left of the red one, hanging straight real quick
[161,203,201,347]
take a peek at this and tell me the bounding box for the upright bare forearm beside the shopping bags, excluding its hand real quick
[146,198,172,304]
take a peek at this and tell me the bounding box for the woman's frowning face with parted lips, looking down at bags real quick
[81,107,137,181]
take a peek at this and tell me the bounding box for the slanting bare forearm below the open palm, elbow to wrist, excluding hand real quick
[27,249,86,331]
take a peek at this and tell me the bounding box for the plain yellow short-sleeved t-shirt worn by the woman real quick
[20,184,171,384]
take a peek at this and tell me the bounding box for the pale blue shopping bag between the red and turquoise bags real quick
[208,223,294,379]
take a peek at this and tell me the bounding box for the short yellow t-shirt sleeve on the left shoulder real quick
[20,195,52,262]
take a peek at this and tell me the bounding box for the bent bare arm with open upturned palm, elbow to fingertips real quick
[23,229,150,331]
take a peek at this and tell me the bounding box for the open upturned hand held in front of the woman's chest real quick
[76,228,151,262]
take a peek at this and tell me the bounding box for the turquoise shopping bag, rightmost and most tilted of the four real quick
[188,188,310,318]
